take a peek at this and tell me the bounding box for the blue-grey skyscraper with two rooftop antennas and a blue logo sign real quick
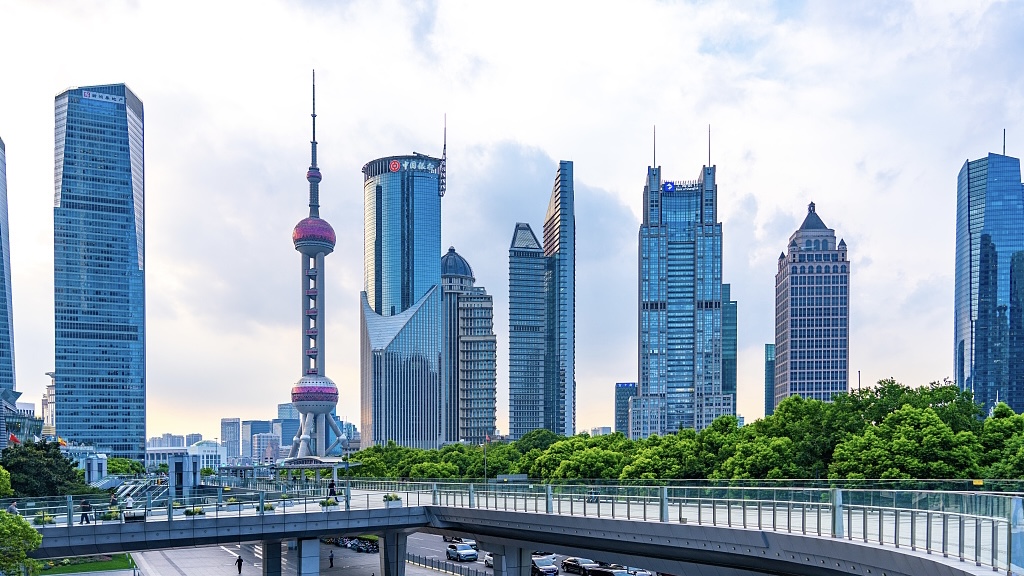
[630,161,736,438]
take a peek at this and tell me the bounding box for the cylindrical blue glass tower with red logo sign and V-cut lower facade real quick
[359,155,443,448]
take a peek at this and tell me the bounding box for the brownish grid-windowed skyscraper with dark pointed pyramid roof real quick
[765,202,851,412]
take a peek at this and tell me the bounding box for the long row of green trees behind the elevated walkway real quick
[351,379,1024,482]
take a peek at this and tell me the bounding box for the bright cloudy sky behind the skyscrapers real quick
[0,0,1024,438]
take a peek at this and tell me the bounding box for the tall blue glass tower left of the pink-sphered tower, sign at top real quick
[53,84,145,461]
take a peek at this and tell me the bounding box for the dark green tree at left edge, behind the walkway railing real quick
[0,441,88,497]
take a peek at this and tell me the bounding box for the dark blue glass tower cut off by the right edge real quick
[953,154,1024,413]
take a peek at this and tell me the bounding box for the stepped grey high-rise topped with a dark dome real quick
[441,243,498,444]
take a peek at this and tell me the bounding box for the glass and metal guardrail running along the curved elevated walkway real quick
[9,481,1024,576]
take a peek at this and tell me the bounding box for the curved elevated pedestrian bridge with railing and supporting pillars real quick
[18,481,1024,576]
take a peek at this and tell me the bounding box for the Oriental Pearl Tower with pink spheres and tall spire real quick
[289,71,344,458]
